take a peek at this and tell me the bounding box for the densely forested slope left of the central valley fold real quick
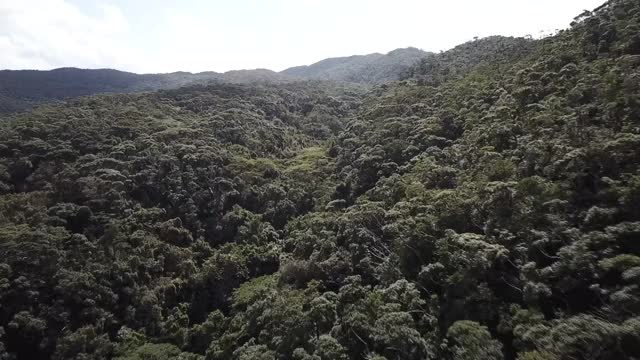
[0,84,359,359]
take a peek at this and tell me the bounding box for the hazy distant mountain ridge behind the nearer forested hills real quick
[0,48,431,113]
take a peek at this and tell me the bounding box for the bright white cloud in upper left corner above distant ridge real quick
[0,0,137,69]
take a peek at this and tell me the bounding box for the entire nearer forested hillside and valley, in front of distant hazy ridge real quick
[0,0,640,360]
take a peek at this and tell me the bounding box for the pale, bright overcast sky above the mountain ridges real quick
[0,0,605,73]
